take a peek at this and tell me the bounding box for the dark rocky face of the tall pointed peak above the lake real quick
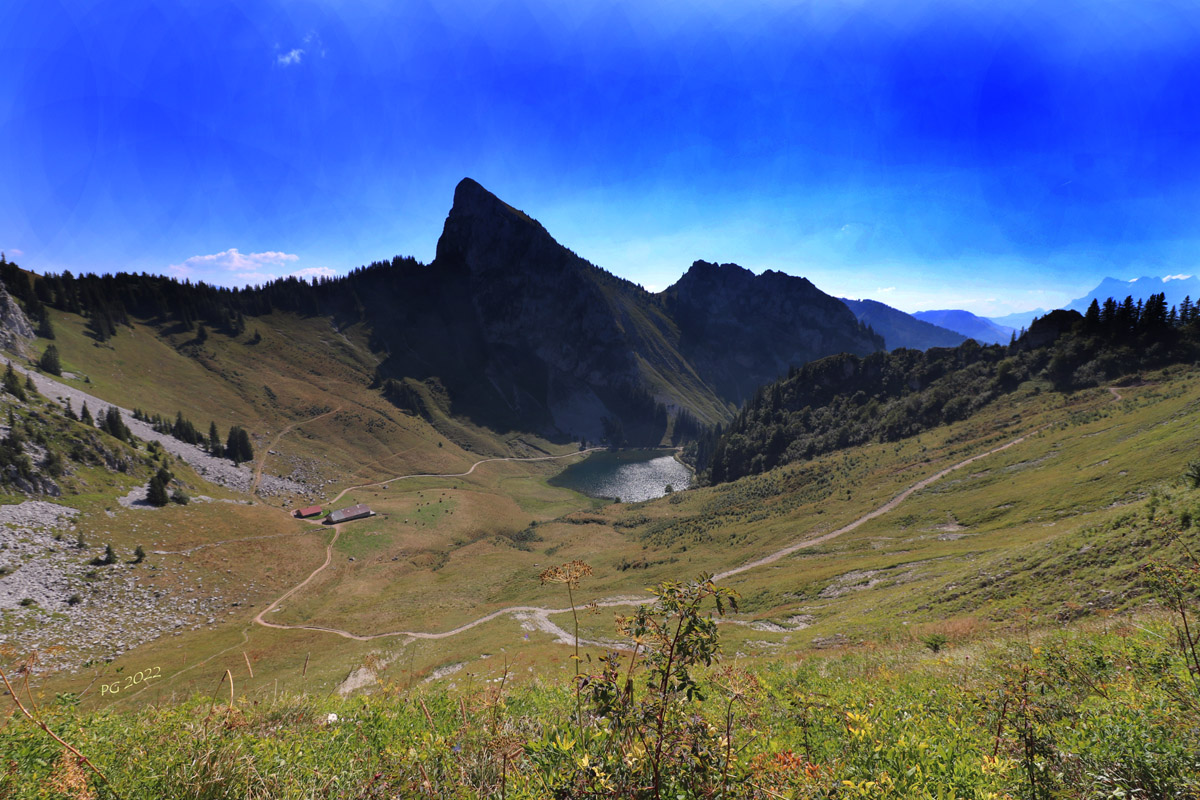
[431,179,667,439]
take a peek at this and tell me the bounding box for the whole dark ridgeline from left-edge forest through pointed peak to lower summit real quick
[0,179,883,445]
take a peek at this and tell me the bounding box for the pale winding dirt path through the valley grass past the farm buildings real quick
[254,426,1045,645]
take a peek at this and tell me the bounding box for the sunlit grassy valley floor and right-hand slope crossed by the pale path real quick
[7,368,1200,705]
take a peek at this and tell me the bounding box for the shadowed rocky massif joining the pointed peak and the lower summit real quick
[362,179,882,443]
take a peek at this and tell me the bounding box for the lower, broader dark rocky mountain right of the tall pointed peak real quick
[664,261,883,404]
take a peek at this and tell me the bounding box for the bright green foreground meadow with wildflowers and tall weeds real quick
[0,592,1200,799]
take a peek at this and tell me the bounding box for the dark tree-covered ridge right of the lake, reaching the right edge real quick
[694,294,1200,483]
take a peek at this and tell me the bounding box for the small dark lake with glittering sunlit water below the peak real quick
[550,450,691,503]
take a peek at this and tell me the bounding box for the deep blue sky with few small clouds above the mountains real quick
[0,0,1200,314]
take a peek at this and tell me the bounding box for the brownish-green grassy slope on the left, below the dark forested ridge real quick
[35,304,549,496]
